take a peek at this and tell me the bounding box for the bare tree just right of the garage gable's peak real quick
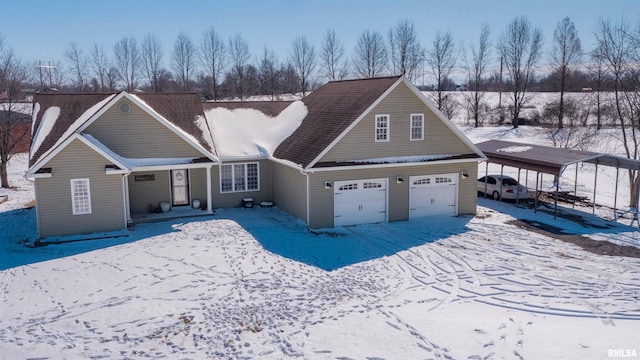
[426,31,458,111]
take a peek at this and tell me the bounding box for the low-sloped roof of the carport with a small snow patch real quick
[476,140,640,175]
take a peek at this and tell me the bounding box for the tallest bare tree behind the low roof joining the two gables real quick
[199,28,225,100]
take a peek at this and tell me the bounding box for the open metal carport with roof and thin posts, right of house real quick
[476,140,640,220]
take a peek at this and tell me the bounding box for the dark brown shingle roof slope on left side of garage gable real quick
[274,76,400,168]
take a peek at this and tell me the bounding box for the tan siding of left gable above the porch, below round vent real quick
[85,100,202,158]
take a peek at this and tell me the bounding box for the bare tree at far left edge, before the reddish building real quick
[0,43,31,188]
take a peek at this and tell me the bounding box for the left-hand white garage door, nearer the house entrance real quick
[333,179,387,226]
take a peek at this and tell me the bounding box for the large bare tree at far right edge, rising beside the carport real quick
[595,19,640,208]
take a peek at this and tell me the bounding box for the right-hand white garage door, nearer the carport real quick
[409,174,458,219]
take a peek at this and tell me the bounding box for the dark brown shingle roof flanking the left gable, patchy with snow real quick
[29,93,214,166]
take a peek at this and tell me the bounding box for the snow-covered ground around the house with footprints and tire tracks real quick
[0,127,640,359]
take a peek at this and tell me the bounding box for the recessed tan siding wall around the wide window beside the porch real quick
[211,160,273,209]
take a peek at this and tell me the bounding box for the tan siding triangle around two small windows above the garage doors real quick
[320,83,473,162]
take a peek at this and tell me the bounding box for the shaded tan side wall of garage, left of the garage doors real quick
[271,162,308,222]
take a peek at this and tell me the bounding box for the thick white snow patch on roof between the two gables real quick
[205,101,308,159]
